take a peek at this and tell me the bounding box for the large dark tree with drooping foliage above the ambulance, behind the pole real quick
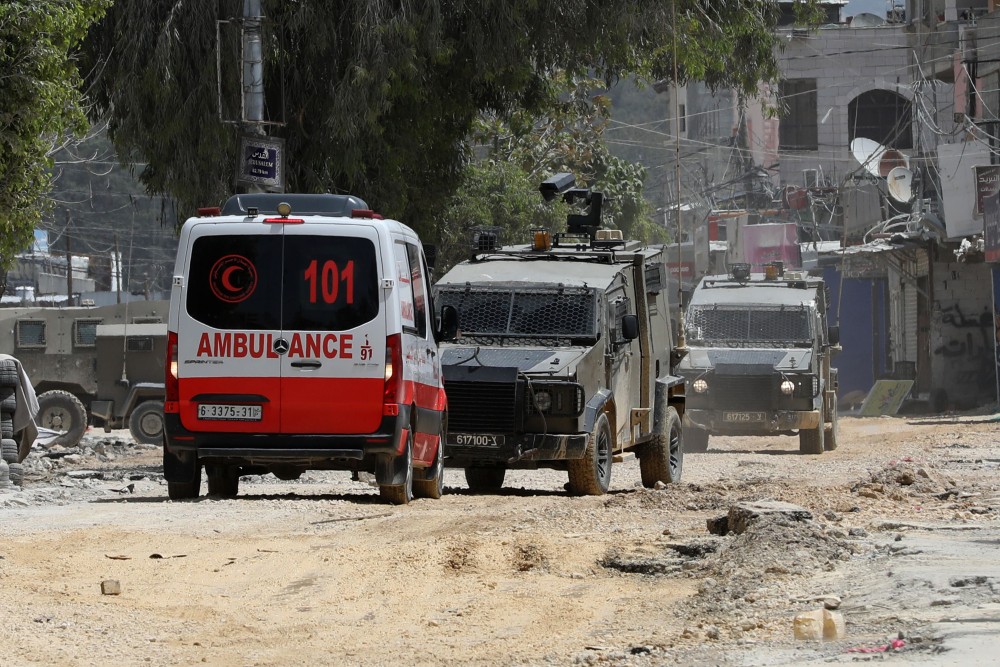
[87,0,808,240]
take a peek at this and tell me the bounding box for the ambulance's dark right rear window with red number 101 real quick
[282,236,380,331]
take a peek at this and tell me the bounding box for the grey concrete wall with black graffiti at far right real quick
[930,262,996,409]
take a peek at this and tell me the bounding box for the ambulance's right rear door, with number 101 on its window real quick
[281,219,391,435]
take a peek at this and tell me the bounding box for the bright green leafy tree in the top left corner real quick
[0,0,111,269]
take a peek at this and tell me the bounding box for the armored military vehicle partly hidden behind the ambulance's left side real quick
[0,301,168,447]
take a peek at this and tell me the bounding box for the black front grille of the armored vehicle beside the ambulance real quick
[444,381,517,433]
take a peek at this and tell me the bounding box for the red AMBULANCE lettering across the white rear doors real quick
[195,331,354,359]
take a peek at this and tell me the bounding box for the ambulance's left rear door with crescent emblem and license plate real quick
[177,221,283,433]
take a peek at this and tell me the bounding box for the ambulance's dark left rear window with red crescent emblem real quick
[187,234,282,331]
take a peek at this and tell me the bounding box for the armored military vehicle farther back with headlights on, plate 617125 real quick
[678,263,840,454]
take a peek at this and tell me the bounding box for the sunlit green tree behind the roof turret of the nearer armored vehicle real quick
[433,73,662,276]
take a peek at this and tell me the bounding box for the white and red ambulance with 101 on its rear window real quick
[163,193,457,504]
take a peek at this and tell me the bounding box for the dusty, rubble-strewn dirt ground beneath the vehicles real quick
[0,415,1000,665]
